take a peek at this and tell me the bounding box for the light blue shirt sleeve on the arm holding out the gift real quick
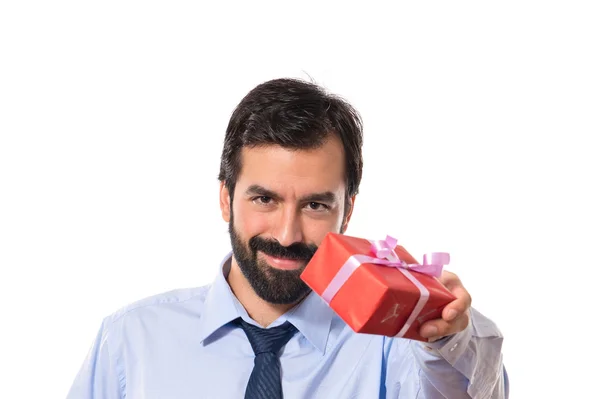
[387,308,508,399]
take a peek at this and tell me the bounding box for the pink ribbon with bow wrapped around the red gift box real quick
[321,236,450,337]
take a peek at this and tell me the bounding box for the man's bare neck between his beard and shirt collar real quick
[227,257,296,327]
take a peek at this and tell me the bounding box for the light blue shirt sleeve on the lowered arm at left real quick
[67,318,124,399]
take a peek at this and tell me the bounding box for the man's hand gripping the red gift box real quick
[419,270,471,342]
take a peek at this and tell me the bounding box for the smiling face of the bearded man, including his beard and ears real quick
[220,136,354,304]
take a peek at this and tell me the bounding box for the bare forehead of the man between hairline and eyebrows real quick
[236,135,345,195]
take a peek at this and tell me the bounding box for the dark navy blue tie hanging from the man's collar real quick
[238,319,298,399]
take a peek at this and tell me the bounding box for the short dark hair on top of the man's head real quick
[219,79,363,216]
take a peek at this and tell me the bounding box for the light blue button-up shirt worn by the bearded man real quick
[67,254,508,399]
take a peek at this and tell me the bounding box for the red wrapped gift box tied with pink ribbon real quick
[301,233,456,342]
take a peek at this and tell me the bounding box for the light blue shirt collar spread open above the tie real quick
[199,252,334,354]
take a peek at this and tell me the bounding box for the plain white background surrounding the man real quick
[0,0,600,399]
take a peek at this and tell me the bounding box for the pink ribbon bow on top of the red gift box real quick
[371,235,450,277]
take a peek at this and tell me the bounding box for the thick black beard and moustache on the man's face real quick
[229,215,317,305]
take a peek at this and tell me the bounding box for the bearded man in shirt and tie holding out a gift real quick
[68,79,508,399]
